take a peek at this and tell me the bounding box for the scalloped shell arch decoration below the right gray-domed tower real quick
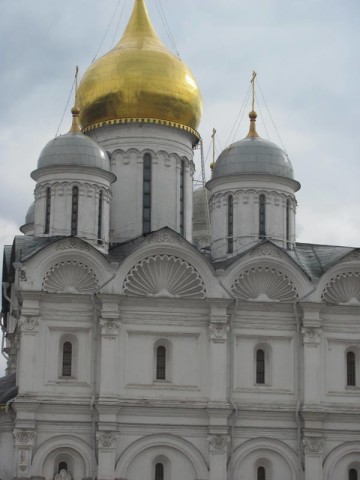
[231,267,298,302]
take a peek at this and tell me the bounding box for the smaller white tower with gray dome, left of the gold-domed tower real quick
[30,108,116,251]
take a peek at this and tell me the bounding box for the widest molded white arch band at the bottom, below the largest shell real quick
[115,434,209,480]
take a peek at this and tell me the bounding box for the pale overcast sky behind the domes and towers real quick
[0,0,360,374]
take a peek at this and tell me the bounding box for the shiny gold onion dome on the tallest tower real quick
[78,0,202,136]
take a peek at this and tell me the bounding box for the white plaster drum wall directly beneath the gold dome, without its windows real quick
[87,123,194,242]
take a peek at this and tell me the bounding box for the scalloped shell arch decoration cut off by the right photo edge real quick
[321,272,360,305]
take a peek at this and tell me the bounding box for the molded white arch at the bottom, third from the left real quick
[230,438,299,480]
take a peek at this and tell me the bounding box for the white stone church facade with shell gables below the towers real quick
[0,229,360,480]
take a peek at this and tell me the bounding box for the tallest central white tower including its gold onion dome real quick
[78,0,202,242]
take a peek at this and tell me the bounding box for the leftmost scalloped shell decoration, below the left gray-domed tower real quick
[42,260,99,294]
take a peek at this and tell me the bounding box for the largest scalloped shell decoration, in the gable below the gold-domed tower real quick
[123,255,206,298]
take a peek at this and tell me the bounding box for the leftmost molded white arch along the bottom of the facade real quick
[31,435,94,477]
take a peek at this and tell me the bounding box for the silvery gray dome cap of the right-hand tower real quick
[212,137,294,180]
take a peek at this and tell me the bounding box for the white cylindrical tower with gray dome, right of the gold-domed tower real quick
[207,111,300,259]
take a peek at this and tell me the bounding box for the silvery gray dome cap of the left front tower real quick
[37,132,110,171]
